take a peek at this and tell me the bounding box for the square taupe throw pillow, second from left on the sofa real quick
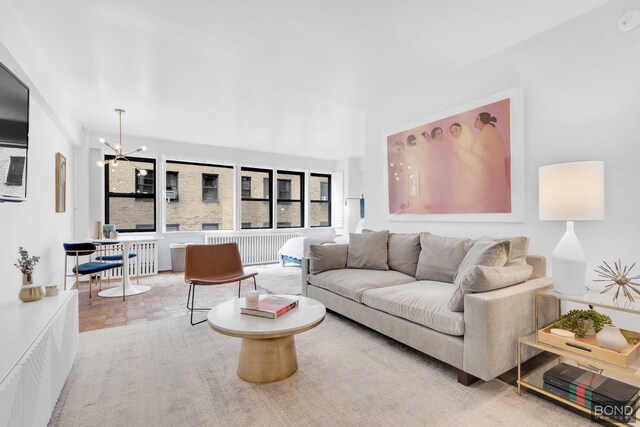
[347,230,389,270]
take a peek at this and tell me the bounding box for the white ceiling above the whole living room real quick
[12,0,608,159]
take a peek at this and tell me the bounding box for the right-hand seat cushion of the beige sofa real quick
[362,281,464,336]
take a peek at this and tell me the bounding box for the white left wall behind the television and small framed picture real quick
[0,52,75,304]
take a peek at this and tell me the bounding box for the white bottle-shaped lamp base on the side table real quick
[551,221,587,295]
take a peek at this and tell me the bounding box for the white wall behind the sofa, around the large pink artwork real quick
[365,1,640,324]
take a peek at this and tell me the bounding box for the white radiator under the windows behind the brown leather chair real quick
[204,233,302,265]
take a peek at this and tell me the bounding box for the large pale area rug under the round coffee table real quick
[50,286,589,427]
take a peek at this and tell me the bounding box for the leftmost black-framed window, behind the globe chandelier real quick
[104,156,156,233]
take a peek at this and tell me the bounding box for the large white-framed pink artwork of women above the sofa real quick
[383,88,524,222]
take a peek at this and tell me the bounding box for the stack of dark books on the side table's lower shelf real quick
[543,363,640,423]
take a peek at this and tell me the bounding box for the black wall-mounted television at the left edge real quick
[0,59,29,202]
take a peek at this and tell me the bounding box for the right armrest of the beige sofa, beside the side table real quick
[463,277,557,381]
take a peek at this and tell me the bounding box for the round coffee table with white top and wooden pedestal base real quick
[208,295,326,383]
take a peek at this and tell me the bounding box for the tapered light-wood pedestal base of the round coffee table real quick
[237,335,298,383]
